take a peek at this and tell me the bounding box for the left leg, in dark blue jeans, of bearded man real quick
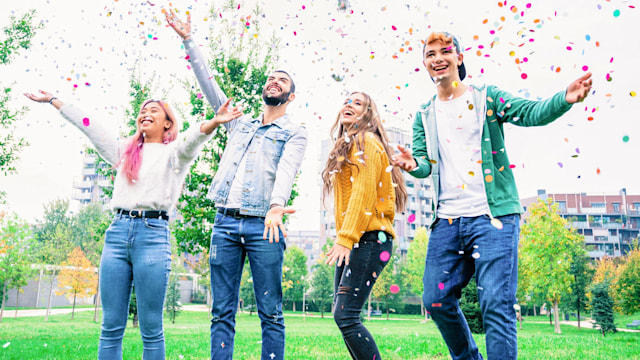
[209,214,245,360]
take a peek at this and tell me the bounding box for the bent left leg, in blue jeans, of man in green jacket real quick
[422,219,482,359]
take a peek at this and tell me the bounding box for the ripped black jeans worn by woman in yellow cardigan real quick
[333,231,393,360]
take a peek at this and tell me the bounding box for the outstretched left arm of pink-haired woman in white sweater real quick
[24,90,121,165]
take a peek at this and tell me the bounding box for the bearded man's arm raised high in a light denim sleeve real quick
[163,10,233,129]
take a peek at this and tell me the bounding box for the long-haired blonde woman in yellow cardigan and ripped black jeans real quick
[322,92,407,360]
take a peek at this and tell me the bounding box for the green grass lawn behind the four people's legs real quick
[0,311,640,360]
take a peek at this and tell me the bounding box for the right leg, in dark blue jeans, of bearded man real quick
[242,218,286,360]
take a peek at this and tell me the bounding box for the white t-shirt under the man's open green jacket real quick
[435,91,490,219]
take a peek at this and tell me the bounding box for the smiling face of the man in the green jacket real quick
[423,38,463,82]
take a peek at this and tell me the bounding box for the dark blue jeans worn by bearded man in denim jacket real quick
[209,213,286,360]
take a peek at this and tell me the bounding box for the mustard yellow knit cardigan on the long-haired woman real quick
[333,132,396,249]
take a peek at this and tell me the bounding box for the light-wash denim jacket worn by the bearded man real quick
[184,39,307,216]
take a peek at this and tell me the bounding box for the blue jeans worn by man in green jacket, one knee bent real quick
[422,214,520,360]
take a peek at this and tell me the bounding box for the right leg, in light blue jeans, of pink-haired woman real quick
[129,219,171,360]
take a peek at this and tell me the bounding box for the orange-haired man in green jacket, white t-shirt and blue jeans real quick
[394,32,591,360]
